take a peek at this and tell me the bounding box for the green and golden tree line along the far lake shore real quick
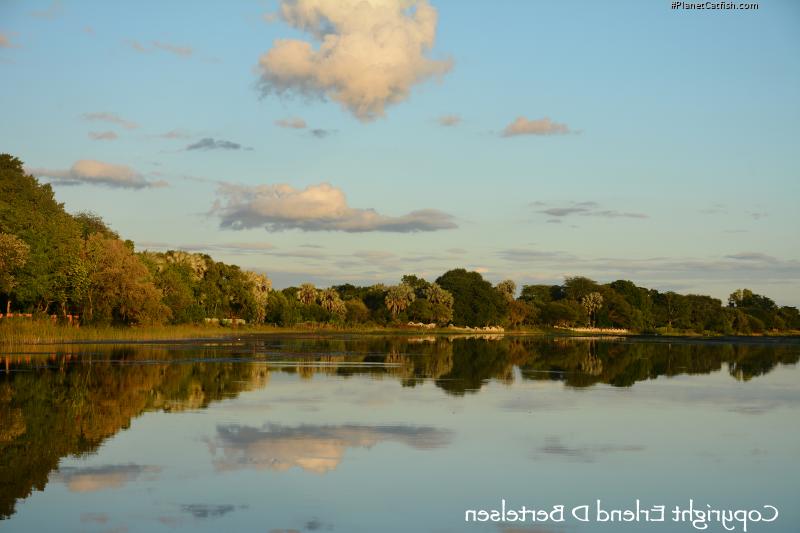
[0,154,800,334]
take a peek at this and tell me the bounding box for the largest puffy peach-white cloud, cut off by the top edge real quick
[258,0,452,121]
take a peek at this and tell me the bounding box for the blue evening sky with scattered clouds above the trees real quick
[0,0,800,305]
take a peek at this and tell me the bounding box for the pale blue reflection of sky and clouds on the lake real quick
[2,360,800,533]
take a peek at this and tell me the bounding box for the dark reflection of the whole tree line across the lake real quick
[0,335,800,517]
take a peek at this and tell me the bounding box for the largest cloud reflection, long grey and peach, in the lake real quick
[209,424,451,474]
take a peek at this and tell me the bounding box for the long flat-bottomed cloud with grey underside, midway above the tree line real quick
[212,183,457,233]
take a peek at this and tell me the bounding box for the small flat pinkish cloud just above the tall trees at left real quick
[28,159,167,189]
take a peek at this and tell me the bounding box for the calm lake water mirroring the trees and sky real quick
[0,335,800,533]
